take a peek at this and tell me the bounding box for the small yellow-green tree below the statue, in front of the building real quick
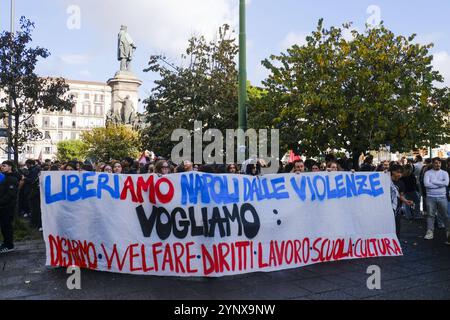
[81,125,141,162]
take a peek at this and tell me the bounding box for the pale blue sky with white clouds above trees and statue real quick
[0,0,450,110]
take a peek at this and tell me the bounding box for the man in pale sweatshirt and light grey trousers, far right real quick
[424,158,450,245]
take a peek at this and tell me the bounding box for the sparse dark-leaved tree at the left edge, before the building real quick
[0,17,73,165]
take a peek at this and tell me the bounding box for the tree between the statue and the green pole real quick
[142,25,238,156]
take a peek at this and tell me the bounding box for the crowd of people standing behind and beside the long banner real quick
[0,154,450,253]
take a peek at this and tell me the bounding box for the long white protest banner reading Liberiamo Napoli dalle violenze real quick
[40,171,402,277]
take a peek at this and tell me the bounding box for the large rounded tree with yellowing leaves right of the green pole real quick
[255,20,449,163]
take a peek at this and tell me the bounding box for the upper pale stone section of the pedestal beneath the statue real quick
[107,71,142,120]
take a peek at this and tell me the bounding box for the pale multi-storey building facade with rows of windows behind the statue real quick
[0,80,111,162]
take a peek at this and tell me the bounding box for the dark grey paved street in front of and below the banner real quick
[0,221,450,300]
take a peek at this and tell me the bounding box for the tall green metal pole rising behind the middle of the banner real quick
[238,0,247,160]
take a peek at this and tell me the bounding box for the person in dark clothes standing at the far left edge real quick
[0,161,19,254]
